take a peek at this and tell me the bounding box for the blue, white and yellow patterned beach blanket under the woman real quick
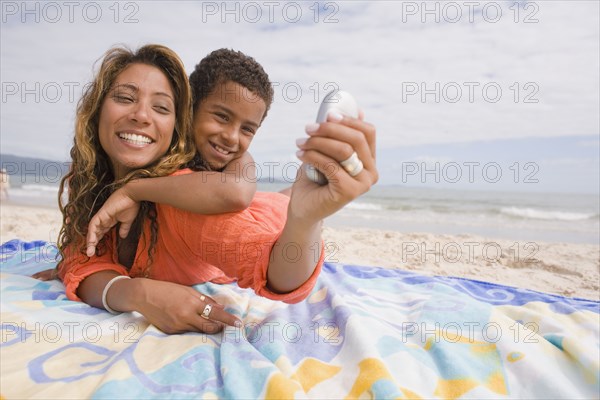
[0,240,600,399]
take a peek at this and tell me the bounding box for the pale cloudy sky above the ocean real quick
[0,0,600,193]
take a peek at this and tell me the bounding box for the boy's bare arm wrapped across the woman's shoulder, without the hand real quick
[123,152,256,214]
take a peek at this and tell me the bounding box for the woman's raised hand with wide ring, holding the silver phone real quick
[290,115,379,222]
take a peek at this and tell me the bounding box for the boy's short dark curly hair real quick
[190,49,273,120]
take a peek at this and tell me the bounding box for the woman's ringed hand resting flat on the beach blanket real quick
[131,279,242,334]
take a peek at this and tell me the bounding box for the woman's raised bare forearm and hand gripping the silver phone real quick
[267,116,379,293]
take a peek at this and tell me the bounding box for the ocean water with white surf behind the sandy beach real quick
[3,176,600,244]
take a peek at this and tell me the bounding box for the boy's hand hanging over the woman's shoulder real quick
[86,185,140,257]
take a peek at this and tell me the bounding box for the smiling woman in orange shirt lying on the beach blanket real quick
[32,46,377,333]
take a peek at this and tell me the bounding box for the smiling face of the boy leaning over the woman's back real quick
[194,81,267,170]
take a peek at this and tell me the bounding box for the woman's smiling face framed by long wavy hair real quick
[98,64,175,179]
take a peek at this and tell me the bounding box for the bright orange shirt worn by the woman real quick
[59,186,324,303]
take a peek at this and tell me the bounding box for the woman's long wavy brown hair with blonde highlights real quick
[58,44,195,266]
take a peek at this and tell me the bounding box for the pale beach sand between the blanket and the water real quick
[0,202,600,301]
